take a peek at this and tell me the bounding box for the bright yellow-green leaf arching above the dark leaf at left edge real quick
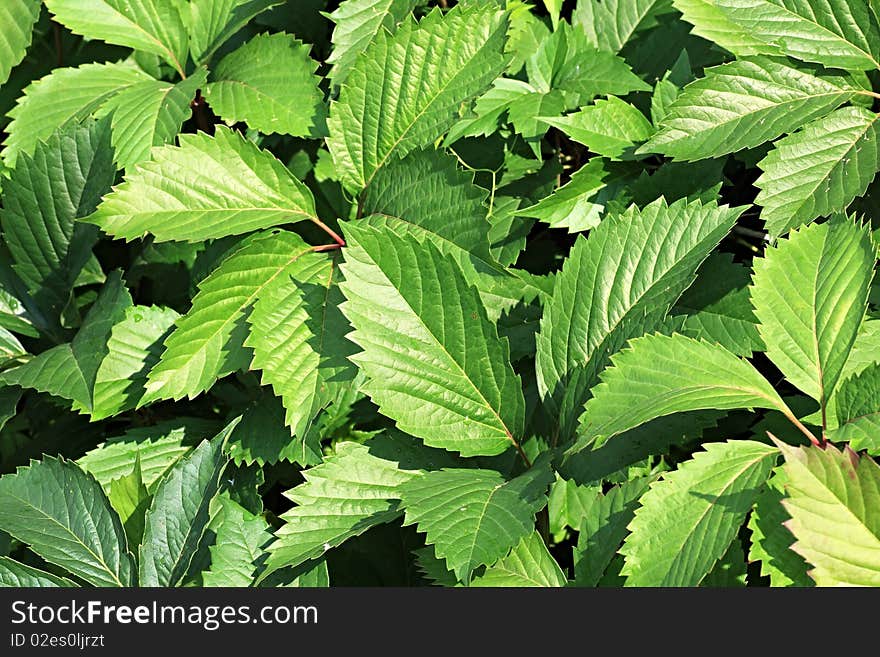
[3,62,151,167]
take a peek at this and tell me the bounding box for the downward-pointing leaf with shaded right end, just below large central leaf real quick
[400,467,552,582]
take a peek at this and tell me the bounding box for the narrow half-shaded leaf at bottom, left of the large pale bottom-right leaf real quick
[574,477,655,586]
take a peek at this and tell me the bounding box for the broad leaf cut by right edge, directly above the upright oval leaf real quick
[755,107,880,238]
